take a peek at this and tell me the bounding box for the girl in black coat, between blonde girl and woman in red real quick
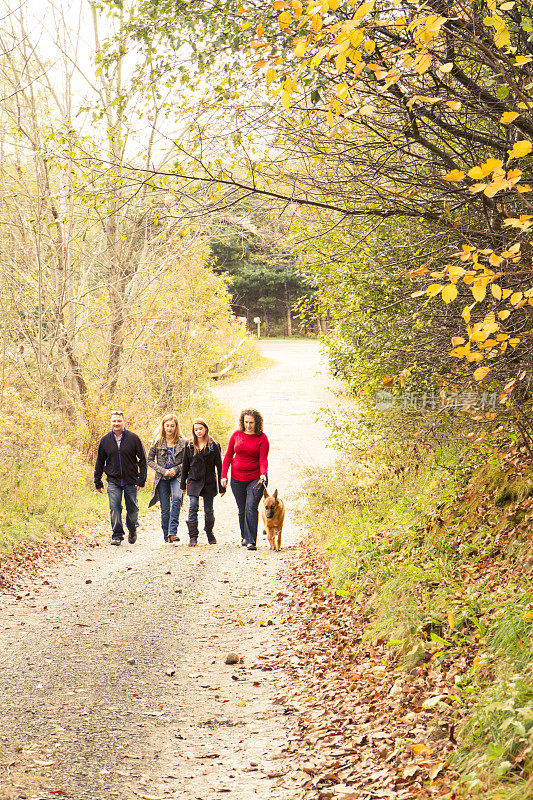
[181,419,226,547]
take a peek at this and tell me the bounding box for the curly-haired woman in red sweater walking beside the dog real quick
[220,408,269,550]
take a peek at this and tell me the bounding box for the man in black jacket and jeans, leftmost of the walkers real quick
[94,411,146,544]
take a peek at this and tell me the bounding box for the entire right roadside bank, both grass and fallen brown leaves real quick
[293,443,533,800]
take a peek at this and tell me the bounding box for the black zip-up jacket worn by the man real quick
[94,428,146,489]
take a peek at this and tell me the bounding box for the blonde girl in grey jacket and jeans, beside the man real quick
[147,414,187,542]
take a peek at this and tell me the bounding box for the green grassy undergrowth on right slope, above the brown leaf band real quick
[302,432,533,800]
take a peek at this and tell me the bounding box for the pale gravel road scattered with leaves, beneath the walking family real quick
[0,341,331,800]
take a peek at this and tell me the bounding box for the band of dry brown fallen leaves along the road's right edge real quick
[272,542,456,800]
